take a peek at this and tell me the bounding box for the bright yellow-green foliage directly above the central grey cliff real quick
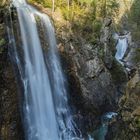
[28,0,119,44]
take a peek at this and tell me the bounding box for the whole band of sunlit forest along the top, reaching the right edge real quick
[28,0,140,43]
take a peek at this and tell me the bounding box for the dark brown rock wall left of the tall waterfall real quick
[0,9,23,140]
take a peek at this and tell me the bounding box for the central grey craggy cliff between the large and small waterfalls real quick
[57,19,127,133]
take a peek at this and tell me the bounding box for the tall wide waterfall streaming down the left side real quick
[7,0,82,140]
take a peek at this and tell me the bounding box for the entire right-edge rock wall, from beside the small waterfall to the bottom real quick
[106,26,140,140]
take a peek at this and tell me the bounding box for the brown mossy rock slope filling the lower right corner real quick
[107,67,140,140]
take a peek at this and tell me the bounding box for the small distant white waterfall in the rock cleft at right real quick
[115,36,128,61]
